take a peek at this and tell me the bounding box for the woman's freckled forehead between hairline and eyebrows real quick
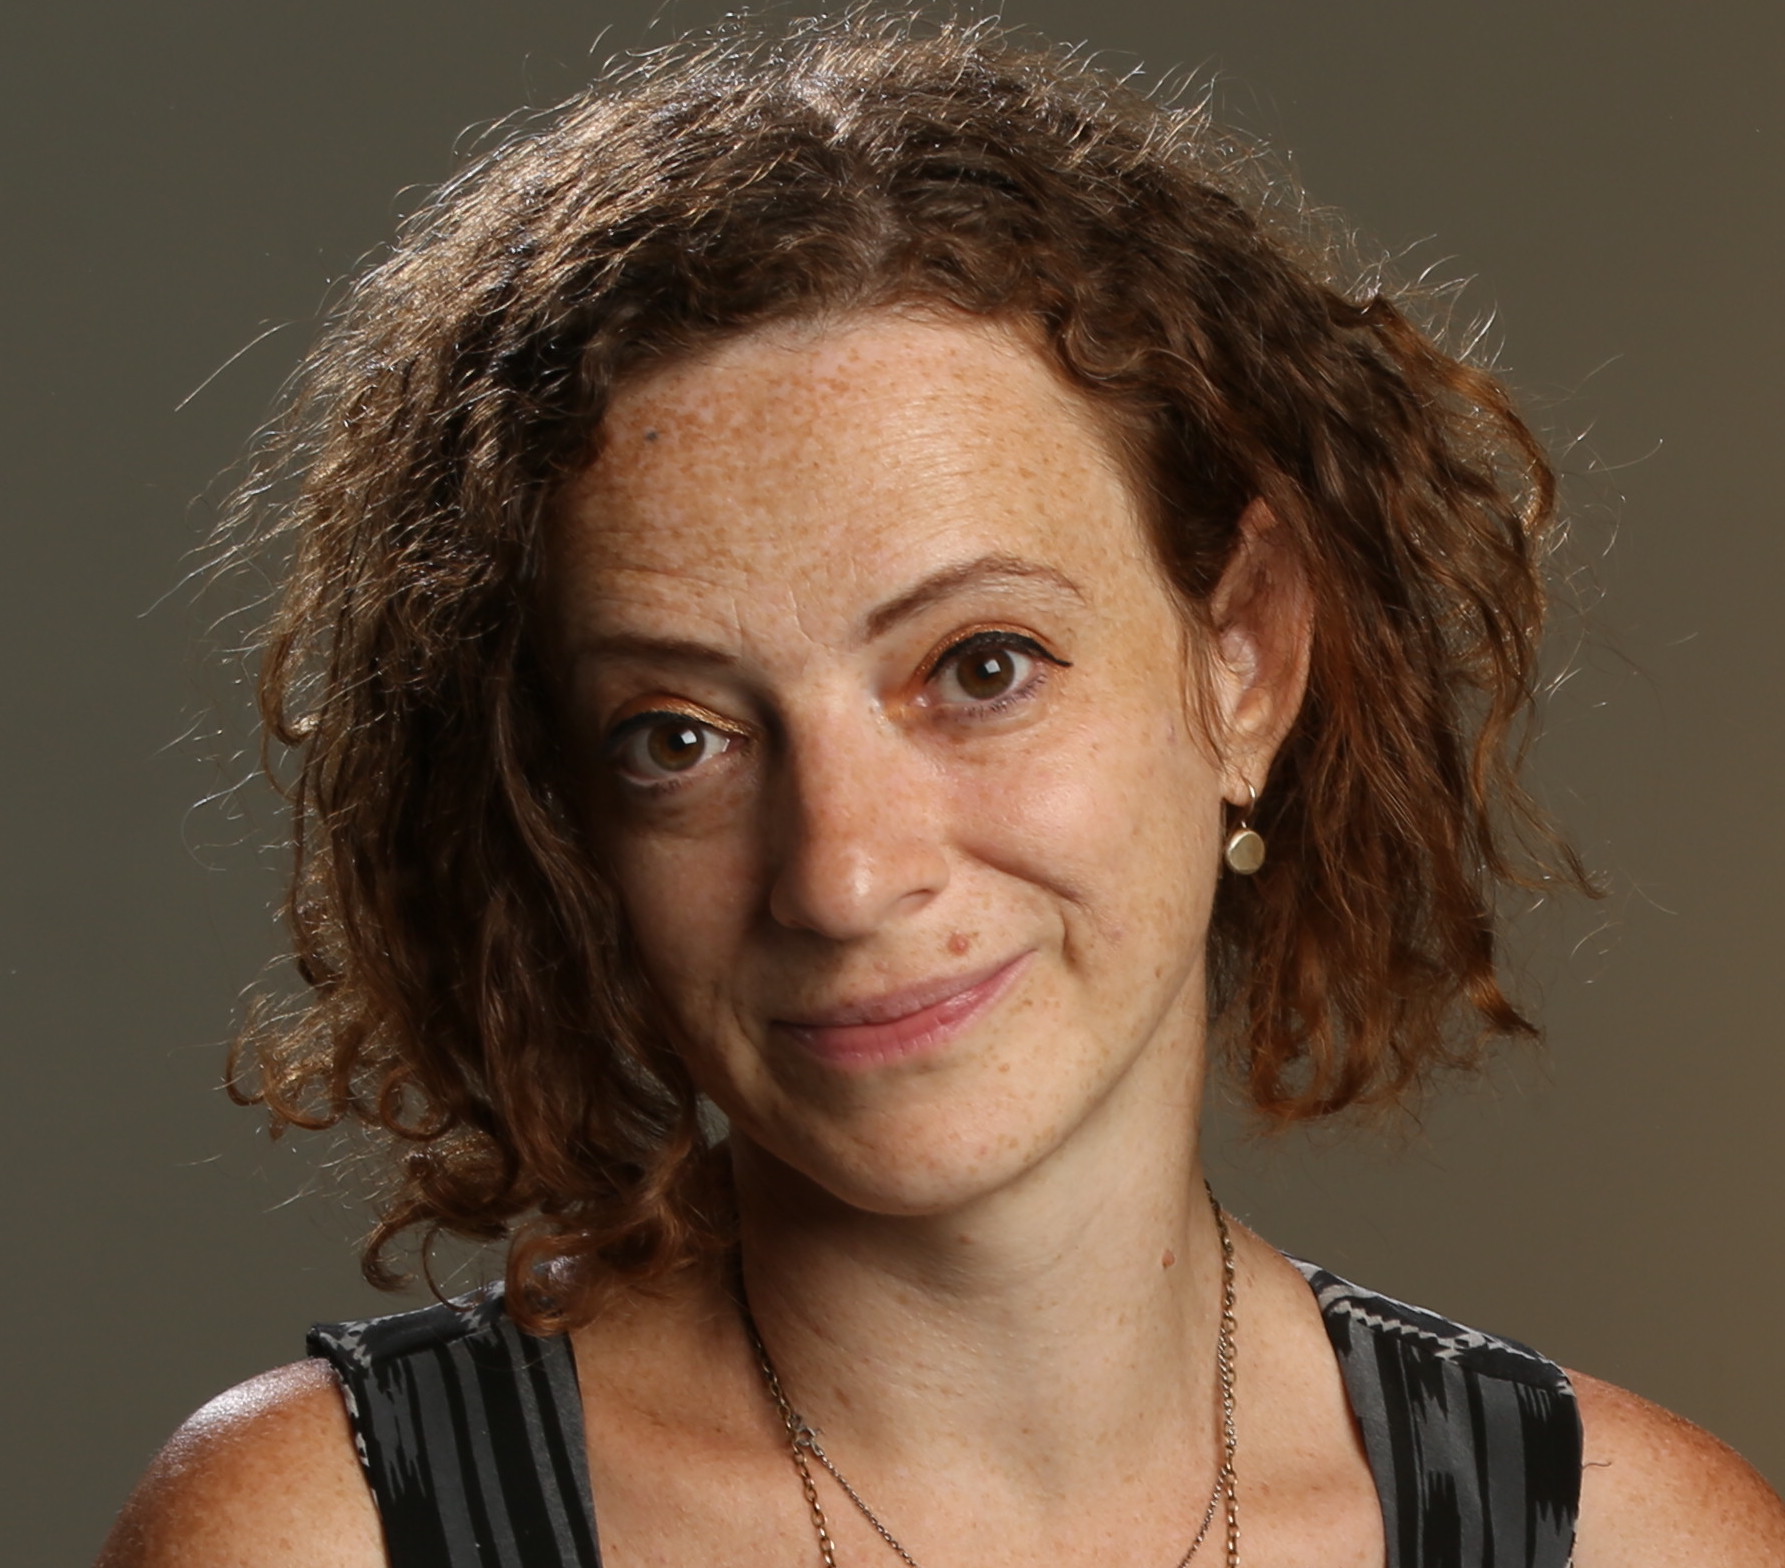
[553,313,1148,635]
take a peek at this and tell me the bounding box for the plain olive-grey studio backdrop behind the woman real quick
[0,0,1785,1564]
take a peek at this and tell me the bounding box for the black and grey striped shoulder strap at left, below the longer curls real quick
[309,1289,602,1568]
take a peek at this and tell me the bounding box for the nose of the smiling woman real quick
[769,718,948,941]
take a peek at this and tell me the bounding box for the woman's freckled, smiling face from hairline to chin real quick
[552,313,1292,1213]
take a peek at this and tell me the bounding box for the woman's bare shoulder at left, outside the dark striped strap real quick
[98,1361,386,1568]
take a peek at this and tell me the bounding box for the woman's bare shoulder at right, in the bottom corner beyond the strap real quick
[1569,1372,1785,1568]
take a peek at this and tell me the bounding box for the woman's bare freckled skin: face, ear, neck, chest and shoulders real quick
[102,314,1785,1568]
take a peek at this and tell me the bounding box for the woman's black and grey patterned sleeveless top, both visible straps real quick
[309,1261,1582,1568]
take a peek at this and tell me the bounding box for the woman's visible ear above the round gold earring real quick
[1208,500,1314,805]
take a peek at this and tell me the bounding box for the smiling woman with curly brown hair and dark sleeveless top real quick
[104,21,1785,1568]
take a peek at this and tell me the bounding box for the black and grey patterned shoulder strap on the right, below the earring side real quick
[1296,1259,1582,1568]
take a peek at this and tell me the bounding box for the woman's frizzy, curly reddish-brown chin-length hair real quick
[219,14,1585,1329]
